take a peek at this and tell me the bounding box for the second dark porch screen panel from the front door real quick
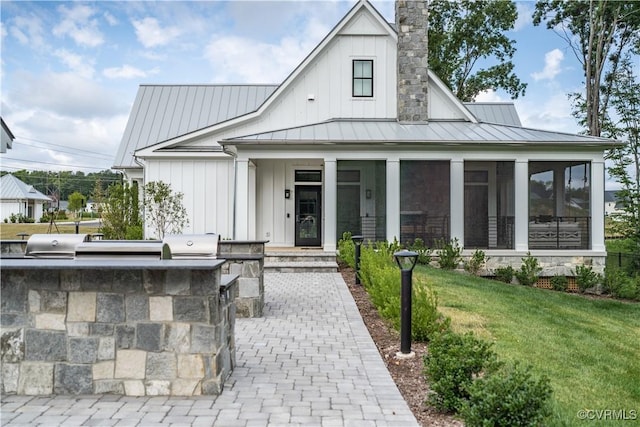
[400,160,450,248]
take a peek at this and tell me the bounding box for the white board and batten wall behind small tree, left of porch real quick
[145,158,234,239]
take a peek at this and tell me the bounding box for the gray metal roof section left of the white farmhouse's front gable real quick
[114,85,278,168]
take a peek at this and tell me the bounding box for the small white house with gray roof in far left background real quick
[0,174,51,222]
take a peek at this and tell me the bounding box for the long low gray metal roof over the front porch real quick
[222,119,618,146]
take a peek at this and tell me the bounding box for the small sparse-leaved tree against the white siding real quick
[144,181,189,239]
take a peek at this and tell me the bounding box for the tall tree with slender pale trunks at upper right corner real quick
[533,0,640,136]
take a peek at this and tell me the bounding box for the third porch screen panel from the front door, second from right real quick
[464,162,515,249]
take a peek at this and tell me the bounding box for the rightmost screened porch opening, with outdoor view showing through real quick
[529,161,591,249]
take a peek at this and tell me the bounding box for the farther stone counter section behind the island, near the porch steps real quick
[218,240,266,317]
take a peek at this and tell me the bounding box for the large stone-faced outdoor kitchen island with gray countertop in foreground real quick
[0,257,237,396]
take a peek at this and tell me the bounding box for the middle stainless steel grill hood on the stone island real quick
[75,240,172,260]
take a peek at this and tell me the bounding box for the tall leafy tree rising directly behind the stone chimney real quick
[428,0,526,101]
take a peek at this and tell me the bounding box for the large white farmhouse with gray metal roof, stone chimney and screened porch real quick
[114,0,616,271]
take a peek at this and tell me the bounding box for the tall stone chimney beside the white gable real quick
[396,0,429,123]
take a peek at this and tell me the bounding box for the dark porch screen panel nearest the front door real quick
[336,160,387,241]
